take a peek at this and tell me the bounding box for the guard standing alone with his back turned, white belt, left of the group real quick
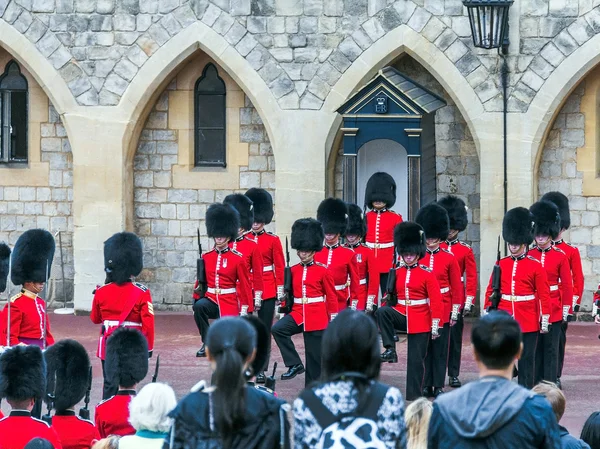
[90,232,154,399]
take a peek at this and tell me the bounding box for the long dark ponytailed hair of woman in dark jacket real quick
[206,318,256,449]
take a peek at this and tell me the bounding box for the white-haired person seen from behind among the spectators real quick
[119,383,177,449]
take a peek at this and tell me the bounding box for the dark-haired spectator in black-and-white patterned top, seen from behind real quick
[294,309,406,449]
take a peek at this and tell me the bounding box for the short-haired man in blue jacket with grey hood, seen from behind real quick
[428,311,560,449]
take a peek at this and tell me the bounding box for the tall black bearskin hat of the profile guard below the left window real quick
[10,229,56,285]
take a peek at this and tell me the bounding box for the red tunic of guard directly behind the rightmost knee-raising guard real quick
[419,248,465,326]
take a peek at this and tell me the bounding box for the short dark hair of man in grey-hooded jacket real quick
[471,310,522,369]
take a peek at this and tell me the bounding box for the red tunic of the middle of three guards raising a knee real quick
[290,262,338,332]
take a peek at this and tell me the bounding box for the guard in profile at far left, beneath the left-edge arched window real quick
[3,229,55,349]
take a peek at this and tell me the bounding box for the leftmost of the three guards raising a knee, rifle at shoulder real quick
[193,203,252,357]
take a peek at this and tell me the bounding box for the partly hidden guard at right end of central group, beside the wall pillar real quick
[438,195,477,388]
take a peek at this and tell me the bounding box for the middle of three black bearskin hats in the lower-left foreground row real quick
[44,340,91,411]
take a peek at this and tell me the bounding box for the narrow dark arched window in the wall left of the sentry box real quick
[194,64,227,167]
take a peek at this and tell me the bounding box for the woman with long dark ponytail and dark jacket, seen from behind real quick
[168,317,289,449]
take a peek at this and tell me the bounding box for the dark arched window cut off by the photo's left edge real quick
[0,61,28,163]
